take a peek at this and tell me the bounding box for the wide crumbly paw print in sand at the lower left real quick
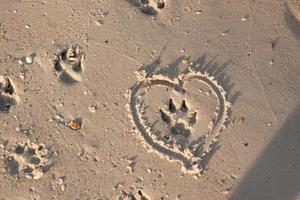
[5,142,53,179]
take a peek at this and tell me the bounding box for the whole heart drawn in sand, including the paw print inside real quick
[126,55,231,174]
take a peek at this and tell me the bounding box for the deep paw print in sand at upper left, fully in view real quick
[53,45,85,84]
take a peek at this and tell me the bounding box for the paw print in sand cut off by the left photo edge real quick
[0,76,19,112]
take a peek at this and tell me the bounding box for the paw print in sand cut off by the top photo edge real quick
[140,0,166,15]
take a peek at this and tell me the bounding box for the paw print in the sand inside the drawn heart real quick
[159,98,197,150]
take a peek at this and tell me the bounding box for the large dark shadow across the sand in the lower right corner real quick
[230,104,300,200]
